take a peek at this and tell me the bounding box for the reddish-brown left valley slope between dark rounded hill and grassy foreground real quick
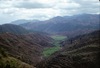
[0,33,52,65]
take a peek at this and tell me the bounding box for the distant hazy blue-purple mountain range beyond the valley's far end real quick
[21,14,100,36]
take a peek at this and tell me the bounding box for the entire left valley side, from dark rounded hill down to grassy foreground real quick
[0,24,53,68]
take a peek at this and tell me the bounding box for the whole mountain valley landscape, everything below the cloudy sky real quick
[0,14,100,68]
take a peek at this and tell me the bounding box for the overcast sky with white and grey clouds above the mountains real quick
[0,0,100,24]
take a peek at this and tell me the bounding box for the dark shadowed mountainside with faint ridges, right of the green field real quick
[37,30,100,68]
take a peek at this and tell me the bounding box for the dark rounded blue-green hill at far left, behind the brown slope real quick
[0,24,29,34]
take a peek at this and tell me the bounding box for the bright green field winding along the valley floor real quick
[43,35,67,57]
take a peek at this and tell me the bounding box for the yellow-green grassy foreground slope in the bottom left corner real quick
[0,47,35,68]
